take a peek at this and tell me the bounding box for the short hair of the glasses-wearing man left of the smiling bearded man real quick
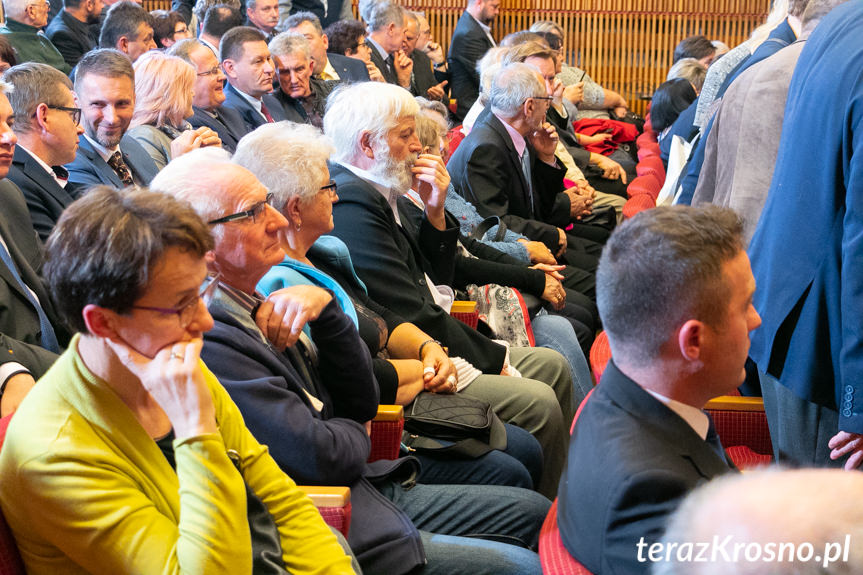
[3,62,72,134]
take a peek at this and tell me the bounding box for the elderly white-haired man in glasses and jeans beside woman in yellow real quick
[154,144,549,574]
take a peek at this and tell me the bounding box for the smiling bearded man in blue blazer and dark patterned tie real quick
[66,49,158,188]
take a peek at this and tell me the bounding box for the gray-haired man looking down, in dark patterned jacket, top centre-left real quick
[269,32,338,129]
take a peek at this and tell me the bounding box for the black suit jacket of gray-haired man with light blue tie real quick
[447,108,570,251]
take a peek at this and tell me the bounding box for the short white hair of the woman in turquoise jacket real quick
[233,122,335,212]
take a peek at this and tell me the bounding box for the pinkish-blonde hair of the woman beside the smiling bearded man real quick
[129,50,195,128]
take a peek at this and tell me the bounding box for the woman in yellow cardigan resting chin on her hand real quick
[0,187,353,574]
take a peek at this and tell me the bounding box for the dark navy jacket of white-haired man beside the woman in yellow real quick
[201,292,425,575]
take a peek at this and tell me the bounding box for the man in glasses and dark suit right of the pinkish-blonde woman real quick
[168,39,248,154]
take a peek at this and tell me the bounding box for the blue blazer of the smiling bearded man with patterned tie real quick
[66,136,159,190]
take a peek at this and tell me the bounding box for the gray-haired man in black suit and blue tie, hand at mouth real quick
[447,63,601,280]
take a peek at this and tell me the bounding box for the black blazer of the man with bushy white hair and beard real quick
[330,164,504,374]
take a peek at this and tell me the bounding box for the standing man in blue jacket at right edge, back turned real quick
[749,2,863,469]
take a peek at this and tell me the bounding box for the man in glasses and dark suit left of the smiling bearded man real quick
[3,62,84,241]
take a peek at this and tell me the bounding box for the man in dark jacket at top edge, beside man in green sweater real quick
[45,0,104,68]
